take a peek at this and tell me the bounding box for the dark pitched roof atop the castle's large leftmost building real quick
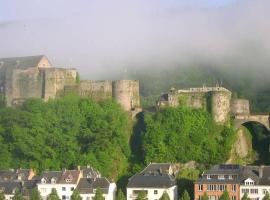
[0,55,45,69]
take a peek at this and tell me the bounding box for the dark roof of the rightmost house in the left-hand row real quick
[76,178,110,194]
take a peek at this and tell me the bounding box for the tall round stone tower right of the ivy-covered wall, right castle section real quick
[211,90,232,124]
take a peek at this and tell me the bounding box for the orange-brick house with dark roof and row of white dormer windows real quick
[194,165,242,200]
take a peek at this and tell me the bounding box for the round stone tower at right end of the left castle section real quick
[112,80,140,111]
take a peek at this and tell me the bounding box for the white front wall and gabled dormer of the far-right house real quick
[240,178,270,200]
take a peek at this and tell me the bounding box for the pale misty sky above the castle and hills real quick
[0,0,270,79]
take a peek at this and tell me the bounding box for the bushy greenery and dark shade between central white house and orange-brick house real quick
[177,168,200,196]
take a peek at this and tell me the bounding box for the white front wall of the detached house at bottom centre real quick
[127,185,178,200]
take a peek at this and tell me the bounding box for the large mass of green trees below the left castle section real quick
[0,95,130,179]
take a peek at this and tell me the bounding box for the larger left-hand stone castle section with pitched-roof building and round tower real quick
[0,55,140,111]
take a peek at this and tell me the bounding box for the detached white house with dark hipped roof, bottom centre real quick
[127,163,178,200]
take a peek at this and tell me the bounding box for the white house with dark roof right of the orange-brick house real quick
[240,166,270,200]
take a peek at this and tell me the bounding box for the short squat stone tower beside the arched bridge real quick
[231,99,250,115]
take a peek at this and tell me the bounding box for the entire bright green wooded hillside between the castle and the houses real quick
[0,95,235,183]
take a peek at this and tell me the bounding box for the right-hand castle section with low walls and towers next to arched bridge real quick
[157,86,250,124]
